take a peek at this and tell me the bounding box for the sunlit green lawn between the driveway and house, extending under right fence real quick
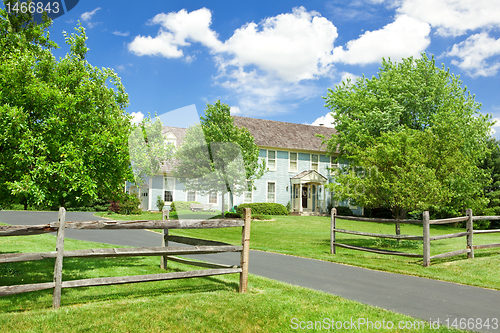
[95,211,500,290]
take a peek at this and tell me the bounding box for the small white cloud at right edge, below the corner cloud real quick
[445,32,500,77]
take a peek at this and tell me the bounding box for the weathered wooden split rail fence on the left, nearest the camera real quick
[0,208,251,308]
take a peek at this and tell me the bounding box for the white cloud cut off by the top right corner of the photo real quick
[393,0,500,36]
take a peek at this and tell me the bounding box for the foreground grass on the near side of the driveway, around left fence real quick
[0,228,460,332]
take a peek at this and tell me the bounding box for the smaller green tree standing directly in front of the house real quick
[174,101,265,217]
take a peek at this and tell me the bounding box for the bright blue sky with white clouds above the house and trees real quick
[3,0,500,138]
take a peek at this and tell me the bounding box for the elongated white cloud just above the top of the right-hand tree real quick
[333,15,431,65]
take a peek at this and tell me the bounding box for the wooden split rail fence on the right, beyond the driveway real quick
[330,208,500,267]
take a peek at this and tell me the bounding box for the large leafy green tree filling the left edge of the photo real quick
[0,10,132,207]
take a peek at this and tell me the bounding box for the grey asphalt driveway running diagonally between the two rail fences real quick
[0,211,500,332]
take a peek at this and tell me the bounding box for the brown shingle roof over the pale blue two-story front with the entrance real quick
[233,116,337,151]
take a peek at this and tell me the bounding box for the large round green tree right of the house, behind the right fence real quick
[325,54,491,218]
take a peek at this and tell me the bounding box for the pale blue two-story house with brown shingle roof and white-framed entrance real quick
[129,116,362,215]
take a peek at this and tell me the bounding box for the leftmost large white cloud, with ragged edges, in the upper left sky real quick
[128,8,222,58]
